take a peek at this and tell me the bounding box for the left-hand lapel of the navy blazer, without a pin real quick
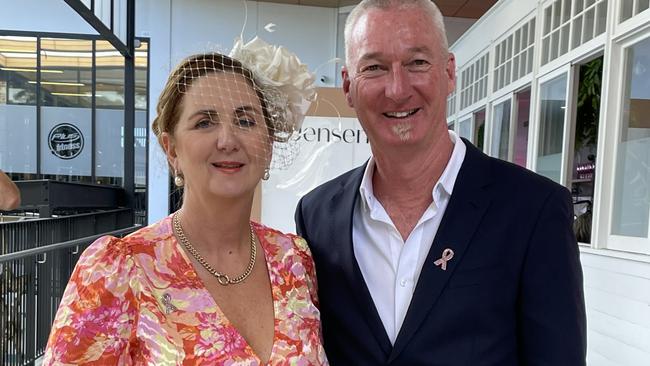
[331,163,392,355]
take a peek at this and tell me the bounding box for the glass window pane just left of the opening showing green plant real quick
[537,75,567,183]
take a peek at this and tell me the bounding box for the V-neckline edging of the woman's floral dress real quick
[168,219,280,365]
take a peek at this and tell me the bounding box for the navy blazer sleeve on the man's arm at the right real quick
[517,188,587,366]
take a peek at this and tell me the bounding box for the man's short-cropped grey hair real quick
[344,0,449,65]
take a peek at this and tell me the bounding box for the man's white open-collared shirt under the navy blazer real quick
[352,131,466,344]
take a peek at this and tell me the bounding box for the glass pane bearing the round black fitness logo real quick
[40,38,93,182]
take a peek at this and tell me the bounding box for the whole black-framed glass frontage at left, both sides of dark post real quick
[0,34,148,223]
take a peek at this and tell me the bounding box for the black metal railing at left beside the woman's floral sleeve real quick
[0,209,140,365]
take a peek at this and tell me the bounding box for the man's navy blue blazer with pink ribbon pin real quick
[295,140,586,366]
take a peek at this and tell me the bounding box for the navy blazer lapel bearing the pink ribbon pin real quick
[389,141,490,362]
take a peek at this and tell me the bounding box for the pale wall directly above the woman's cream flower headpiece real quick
[169,0,338,86]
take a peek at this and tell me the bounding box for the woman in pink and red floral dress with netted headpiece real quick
[44,41,327,365]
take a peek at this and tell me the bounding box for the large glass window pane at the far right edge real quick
[612,39,650,238]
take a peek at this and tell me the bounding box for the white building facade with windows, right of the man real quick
[447,0,650,366]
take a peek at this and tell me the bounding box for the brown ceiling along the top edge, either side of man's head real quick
[262,0,498,19]
